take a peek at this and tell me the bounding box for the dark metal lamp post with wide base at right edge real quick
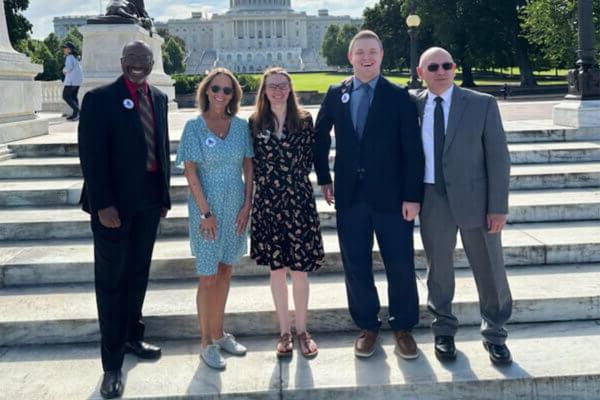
[565,0,600,100]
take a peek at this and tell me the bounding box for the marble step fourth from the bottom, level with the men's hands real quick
[0,189,600,240]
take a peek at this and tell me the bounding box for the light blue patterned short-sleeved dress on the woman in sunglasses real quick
[175,116,254,276]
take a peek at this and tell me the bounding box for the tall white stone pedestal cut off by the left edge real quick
[0,3,48,143]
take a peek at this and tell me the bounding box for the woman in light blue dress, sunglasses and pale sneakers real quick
[176,68,254,369]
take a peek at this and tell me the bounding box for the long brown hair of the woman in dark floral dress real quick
[250,67,308,134]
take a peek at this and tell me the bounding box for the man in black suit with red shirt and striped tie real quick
[78,41,171,398]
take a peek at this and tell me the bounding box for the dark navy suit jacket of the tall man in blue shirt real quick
[314,77,425,212]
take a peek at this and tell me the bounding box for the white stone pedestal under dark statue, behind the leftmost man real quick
[79,24,177,109]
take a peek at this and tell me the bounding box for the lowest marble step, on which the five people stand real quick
[0,321,600,400]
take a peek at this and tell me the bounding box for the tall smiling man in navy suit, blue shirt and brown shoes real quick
[314,31,424,359]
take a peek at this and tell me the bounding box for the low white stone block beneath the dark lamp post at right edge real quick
[552,100,600,128]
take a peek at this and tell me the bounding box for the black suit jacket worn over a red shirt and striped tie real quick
[78,76,171,216]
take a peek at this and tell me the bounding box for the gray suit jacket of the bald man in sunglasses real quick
[416,86,510,229]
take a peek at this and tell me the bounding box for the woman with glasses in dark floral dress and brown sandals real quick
[249,68,324,357]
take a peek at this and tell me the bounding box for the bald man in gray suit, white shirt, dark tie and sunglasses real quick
[417,47,512,364]
